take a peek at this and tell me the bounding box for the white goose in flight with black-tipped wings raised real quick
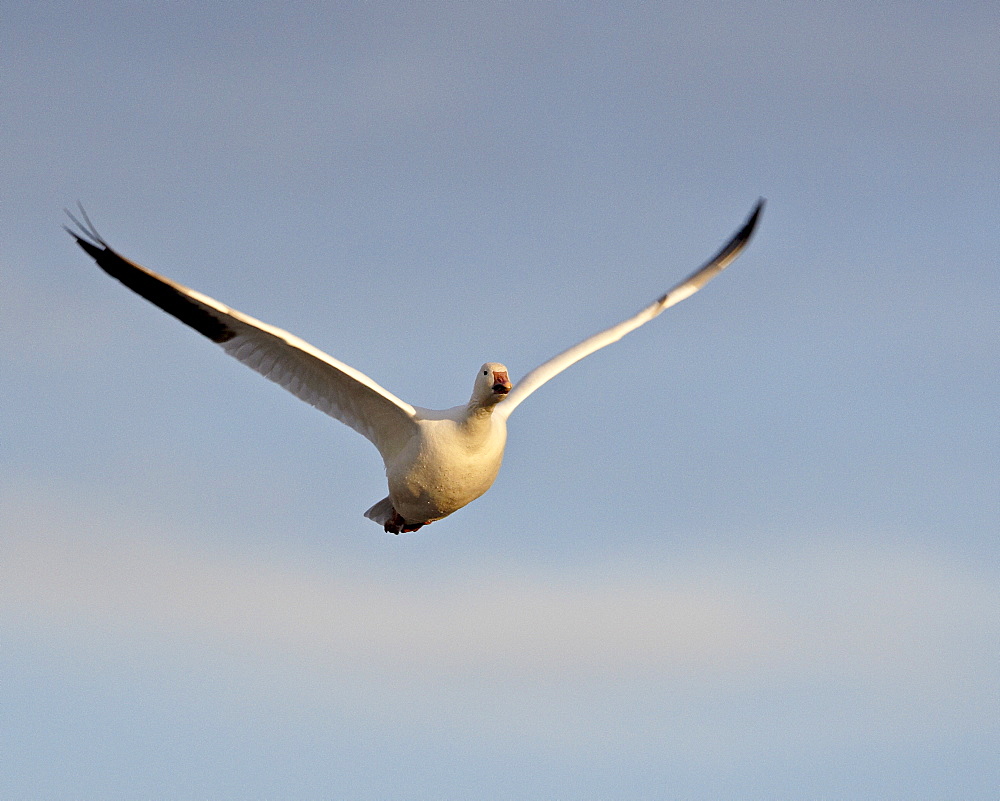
[66,199,764,534]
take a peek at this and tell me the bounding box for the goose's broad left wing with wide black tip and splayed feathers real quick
[66,209,416,454]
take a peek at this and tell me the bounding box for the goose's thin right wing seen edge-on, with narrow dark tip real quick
[494,198,764,417]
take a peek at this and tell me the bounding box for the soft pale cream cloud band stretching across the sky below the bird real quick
[0,499,1000,691]
